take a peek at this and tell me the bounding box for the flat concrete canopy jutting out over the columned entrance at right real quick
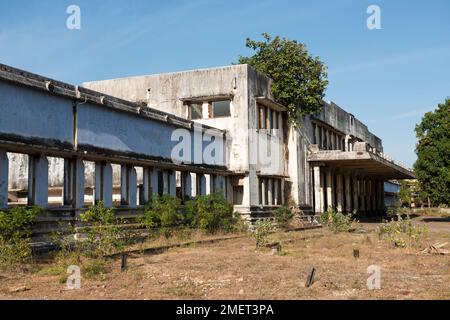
[308,150,415,179]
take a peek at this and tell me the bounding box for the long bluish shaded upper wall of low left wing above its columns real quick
[0,65,227,190]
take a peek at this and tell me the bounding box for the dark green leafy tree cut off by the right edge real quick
[414,99,450,205]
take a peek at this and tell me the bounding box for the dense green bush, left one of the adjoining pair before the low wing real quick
[139,194,183,237]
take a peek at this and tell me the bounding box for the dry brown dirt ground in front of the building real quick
[0,217,450,300]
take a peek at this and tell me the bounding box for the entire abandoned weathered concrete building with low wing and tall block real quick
[0,65,414,234]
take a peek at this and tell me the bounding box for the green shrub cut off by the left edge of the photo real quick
[0,207,42,267]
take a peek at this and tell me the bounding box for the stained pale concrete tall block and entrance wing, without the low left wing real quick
[84,65,412,217]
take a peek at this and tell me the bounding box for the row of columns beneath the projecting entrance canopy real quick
[313,166,384,214]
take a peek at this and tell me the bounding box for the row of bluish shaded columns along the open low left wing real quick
[0,150,226,208]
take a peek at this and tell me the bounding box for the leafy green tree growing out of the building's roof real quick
[239,33,328,124]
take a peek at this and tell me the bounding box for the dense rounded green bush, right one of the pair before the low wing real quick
[186,193,237,233]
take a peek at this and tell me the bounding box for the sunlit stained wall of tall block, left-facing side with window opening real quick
[83,65,248,171]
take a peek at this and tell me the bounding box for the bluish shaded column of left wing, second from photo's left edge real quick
[28,155,48,208]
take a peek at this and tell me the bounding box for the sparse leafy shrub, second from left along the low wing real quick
[80,202,124,257]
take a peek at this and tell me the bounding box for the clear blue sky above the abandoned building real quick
[0,0,450,165]
